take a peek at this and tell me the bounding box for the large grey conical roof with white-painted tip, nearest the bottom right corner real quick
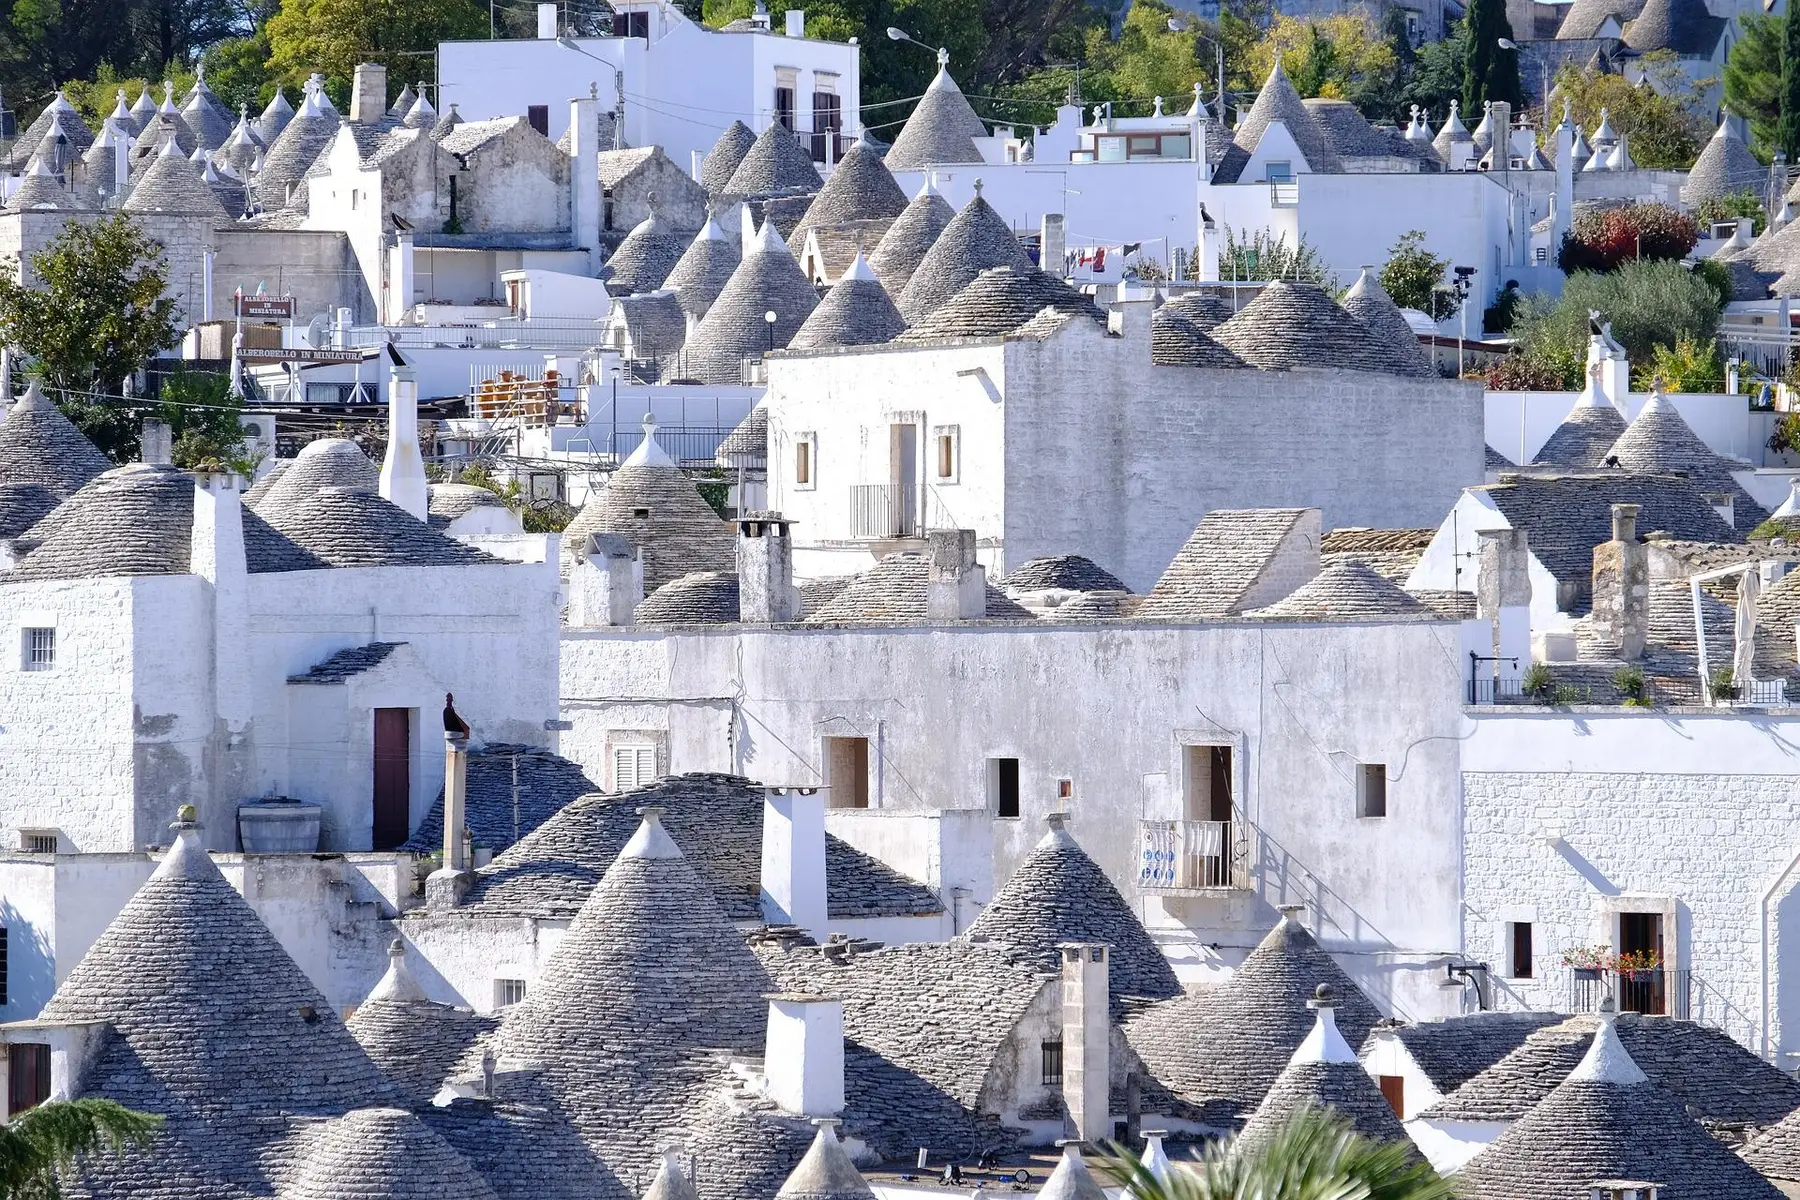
[1456,1022,1782,1200]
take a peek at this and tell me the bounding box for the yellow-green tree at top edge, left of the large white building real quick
[266,0,488,103]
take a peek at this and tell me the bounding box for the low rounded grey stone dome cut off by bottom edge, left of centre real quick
[281,1108,495,1200]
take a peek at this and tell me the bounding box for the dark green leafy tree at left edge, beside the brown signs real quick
[0,212,176,462]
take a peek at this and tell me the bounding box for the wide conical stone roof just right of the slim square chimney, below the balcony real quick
[1125,910,1381,1119]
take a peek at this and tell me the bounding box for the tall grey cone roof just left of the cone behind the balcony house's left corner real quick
[668,221,819,385]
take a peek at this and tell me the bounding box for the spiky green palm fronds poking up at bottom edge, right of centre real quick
[1100,1106,1454,1200]
